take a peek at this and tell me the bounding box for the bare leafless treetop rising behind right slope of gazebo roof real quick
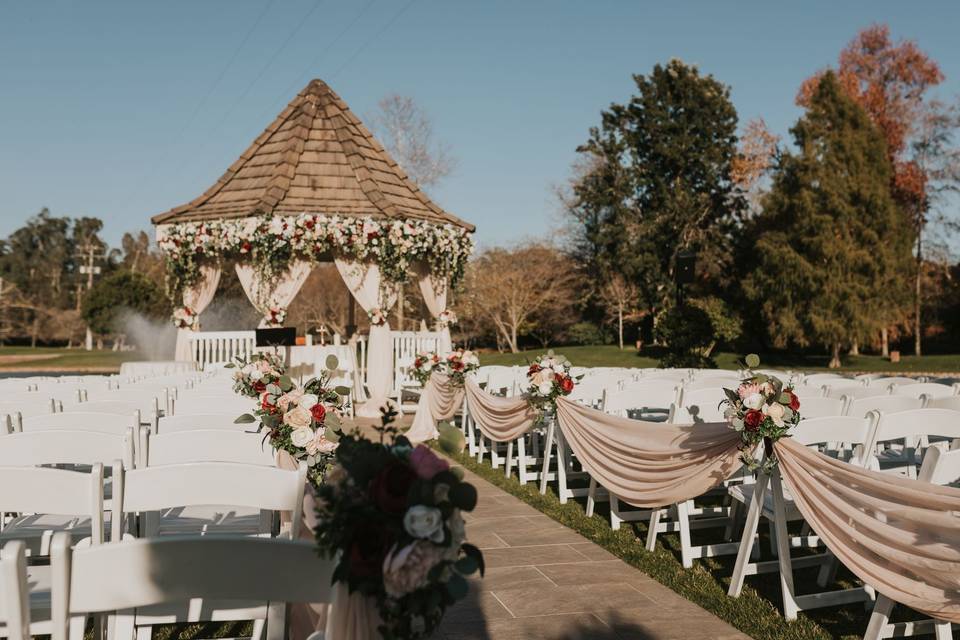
[370,93,456,189]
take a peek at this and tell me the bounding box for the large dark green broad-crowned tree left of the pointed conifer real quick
[567,60,743,324]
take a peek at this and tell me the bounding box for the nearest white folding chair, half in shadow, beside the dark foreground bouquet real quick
[51,537,335,640]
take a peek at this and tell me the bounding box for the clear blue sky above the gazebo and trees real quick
[0,0,960,250]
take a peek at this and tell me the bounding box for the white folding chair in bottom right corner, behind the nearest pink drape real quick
[863,447,960,640]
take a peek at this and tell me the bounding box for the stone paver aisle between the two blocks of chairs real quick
[438,464,748,640]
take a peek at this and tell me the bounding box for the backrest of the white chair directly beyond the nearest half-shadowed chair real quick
[112,462,307,544]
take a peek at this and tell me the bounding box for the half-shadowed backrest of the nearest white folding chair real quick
[51,534,335,640]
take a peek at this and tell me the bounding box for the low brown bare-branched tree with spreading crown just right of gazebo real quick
[457,244,576,353]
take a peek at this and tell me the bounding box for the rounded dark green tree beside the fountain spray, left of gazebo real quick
[82,271,170,335]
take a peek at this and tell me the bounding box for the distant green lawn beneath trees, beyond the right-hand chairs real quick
[480,345,960,373]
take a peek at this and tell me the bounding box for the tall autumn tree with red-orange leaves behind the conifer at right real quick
[797,25,943,355]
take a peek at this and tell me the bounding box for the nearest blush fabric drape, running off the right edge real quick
[774,438,960,623]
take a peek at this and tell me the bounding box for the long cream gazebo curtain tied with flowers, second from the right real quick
[334,258,397,418]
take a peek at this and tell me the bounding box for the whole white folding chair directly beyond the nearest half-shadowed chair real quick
[111,462,307,540]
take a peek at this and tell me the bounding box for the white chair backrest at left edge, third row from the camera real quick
[0,428,134,469]
